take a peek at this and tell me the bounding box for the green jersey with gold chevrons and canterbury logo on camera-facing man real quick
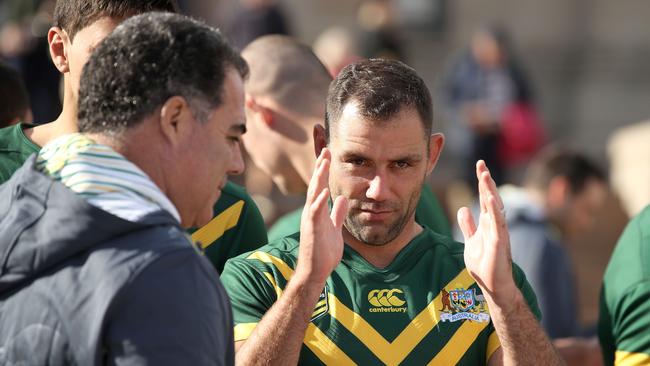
[221,229,540,365]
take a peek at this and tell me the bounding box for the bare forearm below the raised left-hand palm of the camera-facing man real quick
[236,276,325,365]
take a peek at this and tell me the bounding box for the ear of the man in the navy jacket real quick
[159,96,191,146]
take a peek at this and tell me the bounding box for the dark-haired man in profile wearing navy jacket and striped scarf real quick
[0,13,248,365]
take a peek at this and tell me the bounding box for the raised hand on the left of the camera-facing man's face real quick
[294,148,348,291]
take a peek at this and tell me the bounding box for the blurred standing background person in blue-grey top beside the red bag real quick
[444,26,532,192]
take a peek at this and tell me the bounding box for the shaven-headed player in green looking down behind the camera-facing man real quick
[242,35,451,239]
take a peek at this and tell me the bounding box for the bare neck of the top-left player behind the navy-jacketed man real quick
[25,86,79,147]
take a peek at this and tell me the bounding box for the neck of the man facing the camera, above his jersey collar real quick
[343,218,423,268]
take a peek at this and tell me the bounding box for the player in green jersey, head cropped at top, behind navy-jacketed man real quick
[0,0,267,271]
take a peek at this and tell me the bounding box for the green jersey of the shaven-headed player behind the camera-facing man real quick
[269,185,451,242]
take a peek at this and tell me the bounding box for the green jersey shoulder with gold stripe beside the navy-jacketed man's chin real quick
[191,182,268,273]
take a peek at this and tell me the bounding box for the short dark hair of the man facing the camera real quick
[325,59,433,141]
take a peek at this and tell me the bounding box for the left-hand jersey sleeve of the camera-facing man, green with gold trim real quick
[221,258,279,342]
